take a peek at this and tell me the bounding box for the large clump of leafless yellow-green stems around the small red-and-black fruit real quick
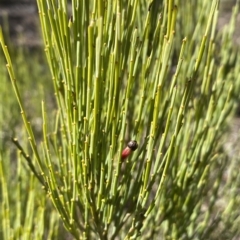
[0,0,240,239]
